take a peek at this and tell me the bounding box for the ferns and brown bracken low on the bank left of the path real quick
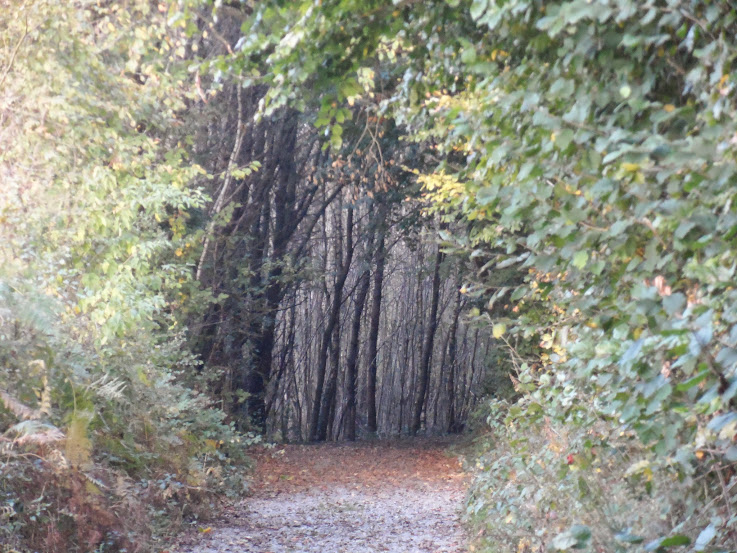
[0,285,258,553]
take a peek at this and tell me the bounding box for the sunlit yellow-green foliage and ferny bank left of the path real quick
[0,0,254,552]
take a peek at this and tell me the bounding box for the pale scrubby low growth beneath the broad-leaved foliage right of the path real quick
[467,390,733,552]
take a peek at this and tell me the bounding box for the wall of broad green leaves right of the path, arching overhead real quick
[220,0,737,551]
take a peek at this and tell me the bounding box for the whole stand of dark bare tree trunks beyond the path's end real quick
[184,15,490,440]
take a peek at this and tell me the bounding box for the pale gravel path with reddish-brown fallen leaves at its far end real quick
[172,438,467,553]
